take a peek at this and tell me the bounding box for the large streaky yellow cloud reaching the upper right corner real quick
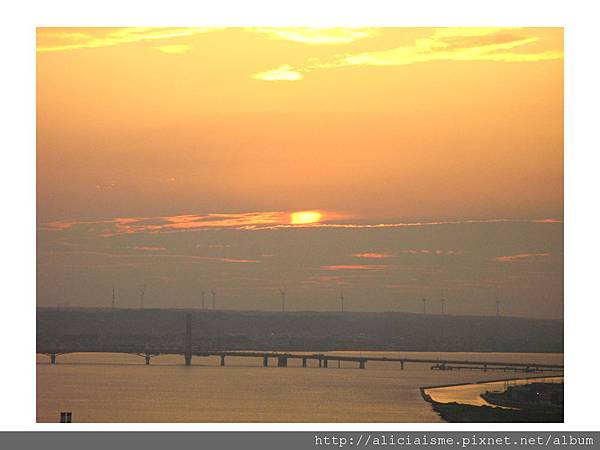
[253,28,563,80]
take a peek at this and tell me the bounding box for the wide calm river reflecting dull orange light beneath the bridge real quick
[37,351,563,423]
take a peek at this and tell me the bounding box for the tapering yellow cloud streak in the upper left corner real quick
[36,27,220,52]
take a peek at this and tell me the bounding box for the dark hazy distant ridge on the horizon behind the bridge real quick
[37,308,563,352]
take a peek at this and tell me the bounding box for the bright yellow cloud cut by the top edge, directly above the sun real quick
[246,27,378,45]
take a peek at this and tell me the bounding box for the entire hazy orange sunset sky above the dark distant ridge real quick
[36,28,563,318]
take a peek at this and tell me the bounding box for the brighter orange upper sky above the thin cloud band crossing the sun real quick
[37,28,563,220]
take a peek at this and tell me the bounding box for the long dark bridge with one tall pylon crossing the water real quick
[37,314,564,372]
